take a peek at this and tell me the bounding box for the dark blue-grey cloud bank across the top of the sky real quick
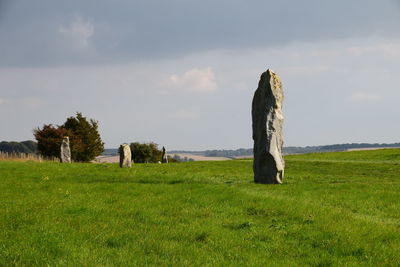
[0,0,400,66]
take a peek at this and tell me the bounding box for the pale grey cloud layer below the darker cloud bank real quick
[0,38,400,149]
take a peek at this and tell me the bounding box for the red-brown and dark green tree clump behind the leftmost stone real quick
[33,112,104,162]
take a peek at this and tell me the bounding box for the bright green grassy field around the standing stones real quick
[0,149,400,266]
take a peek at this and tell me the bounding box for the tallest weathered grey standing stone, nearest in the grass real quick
[251,69,285,184]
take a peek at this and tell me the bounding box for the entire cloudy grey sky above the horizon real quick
[0,0,400,150]
